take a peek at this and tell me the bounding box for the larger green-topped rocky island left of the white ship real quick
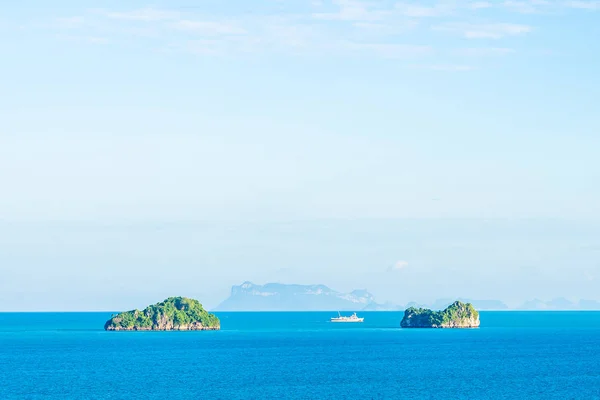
[104,297,221,331]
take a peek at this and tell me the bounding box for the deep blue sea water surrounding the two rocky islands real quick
[0,312,600,399]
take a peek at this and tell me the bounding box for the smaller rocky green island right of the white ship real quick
[400,301,479,328]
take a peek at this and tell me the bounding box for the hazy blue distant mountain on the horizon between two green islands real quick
[214,282,376,311]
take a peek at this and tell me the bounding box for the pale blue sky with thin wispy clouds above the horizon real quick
[0,0,600,311]
